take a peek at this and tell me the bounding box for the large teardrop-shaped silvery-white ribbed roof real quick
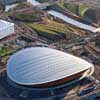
[7,47,93,85]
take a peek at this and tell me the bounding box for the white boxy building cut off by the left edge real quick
[0,20,14,40]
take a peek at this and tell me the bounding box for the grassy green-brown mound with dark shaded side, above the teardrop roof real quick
[27,20,84,39]
